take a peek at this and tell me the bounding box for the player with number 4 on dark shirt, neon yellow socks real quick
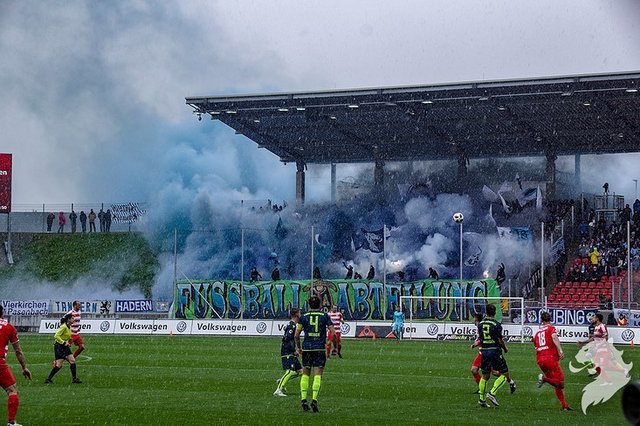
[295,296,337,413]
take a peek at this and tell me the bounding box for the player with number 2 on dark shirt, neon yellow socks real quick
[478,305,509,407]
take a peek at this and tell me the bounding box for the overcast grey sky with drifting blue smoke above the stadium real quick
[0,0,640,204]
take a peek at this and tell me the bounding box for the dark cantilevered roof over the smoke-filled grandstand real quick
[186,71,640,163]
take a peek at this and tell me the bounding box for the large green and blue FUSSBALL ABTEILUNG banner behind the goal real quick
[171,279,501,321]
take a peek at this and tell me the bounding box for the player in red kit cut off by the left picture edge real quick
[0,305,31,425]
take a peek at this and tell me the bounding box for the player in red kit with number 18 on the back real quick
[533,312,573,411]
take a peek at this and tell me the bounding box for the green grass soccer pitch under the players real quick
[6,334,640,425]
